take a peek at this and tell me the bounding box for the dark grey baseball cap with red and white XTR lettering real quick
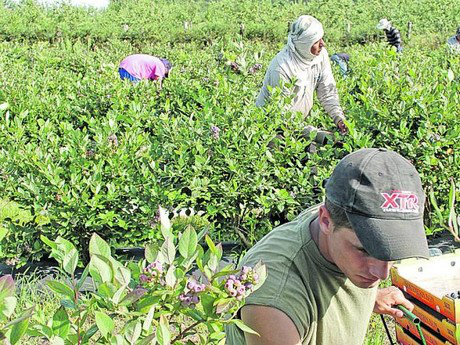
[326,148,429,261]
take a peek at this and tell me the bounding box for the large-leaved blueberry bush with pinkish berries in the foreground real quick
[0,214,266,345]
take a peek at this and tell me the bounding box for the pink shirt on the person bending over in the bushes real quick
[120,54,166,80]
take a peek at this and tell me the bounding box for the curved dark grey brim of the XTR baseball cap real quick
[347,213,429,261]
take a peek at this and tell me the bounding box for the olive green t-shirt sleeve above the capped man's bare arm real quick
[245,260,312,339]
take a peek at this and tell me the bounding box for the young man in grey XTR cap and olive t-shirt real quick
[226,149,428,345]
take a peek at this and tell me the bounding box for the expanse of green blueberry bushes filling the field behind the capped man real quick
[0,0,460,345]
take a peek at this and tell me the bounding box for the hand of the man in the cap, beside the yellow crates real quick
[374,286,414,317]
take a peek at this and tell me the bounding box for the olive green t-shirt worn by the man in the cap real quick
[226,205,377,345]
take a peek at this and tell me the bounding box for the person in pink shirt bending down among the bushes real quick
[118,54,172,88]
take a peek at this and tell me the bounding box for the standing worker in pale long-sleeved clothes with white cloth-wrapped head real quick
[256,16,347,138]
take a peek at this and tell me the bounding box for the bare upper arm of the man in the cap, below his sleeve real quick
[241,305,301,345]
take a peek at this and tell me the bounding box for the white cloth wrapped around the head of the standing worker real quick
[287,16,324,65]
